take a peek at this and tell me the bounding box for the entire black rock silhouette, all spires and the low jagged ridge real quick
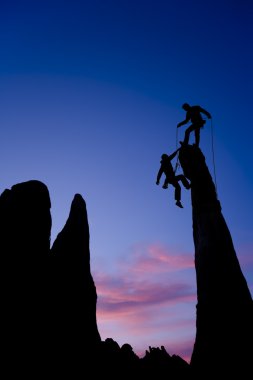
[0,145,253,379]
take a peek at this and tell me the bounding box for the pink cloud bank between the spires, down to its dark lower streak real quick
[94,245,195,313]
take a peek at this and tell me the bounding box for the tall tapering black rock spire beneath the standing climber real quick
[179,145,253,377]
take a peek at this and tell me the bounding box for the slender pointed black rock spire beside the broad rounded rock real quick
[51,194,101,368]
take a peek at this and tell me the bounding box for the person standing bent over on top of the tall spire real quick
[177,103,211,147]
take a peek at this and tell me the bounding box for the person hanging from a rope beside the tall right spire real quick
[156,148,191,208]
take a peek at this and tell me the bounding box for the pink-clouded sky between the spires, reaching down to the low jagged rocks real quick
[94,244,196,360]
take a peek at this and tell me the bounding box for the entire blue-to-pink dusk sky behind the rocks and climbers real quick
[0,0,253,360]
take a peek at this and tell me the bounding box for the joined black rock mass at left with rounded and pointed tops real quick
[0,180,101,378]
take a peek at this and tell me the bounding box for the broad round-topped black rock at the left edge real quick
[0,181,51,377]
